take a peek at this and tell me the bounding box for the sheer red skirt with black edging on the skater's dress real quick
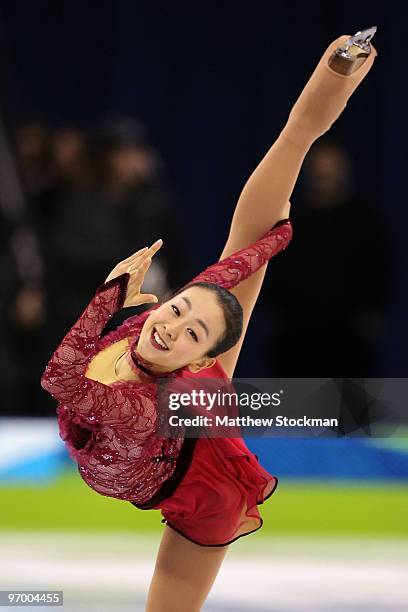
[154,362,278,546]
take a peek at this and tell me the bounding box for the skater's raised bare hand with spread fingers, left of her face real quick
[105,238,163,308]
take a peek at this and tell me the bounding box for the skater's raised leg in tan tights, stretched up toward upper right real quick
[219,36,377,377]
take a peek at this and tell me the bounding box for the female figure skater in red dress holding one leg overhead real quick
[41,31,377,612]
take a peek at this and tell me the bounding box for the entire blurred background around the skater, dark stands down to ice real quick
[0,0,408,612]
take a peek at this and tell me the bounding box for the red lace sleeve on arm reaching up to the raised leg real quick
[188,219,293,289]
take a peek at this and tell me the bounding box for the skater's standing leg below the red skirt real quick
[145,525,228,612]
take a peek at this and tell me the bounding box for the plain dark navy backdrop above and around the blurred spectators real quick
[0,1,408,376]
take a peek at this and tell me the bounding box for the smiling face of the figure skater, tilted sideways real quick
[137,287,225,373]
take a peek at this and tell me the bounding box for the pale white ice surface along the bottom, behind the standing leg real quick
[0,532,408,612]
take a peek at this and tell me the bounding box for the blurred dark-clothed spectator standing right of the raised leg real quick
[262,137,393,377]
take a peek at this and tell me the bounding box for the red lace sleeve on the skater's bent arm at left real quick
[41,273,155,430]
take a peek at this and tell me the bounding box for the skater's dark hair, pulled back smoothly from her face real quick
[165,281,243,357]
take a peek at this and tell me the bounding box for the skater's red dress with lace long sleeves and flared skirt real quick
[41,219,292,546]
